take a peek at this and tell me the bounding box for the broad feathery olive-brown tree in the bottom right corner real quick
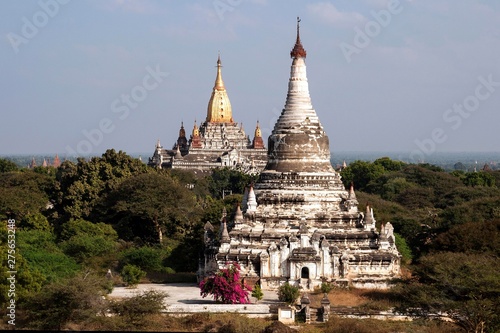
[399,252,500,332]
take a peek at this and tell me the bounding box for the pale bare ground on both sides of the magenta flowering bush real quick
[109,283,278,304]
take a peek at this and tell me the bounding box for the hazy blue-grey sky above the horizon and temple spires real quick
[0,0,500,158]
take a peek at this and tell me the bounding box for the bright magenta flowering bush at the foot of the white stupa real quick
[200,262,252,304]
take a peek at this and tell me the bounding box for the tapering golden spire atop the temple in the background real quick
[207,54,233,123]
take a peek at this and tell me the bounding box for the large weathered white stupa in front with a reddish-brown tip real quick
[199,20,400,290]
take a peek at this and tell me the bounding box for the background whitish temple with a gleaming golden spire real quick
[148,56,267,173]
